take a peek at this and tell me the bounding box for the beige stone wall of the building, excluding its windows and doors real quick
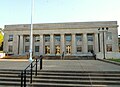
[4,21,118,56]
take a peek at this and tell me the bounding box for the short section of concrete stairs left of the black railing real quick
[0,69,20,87]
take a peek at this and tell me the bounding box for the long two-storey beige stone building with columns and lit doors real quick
[3,21,119,58]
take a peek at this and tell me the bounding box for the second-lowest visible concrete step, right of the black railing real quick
[33,79,120,85]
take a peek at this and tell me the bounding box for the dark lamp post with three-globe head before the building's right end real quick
[98,27,108,59]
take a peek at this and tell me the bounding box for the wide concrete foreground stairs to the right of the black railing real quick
[29,70,120,87]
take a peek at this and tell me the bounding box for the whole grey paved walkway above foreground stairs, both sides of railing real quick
[0,59,120,71]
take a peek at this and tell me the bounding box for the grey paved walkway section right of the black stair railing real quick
[43,60,120,71]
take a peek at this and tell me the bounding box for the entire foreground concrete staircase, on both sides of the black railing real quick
[0,70,120,87]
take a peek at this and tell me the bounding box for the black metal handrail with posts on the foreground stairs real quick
[20,56,42,87]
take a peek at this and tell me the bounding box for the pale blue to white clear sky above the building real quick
[0,0,120,35]
